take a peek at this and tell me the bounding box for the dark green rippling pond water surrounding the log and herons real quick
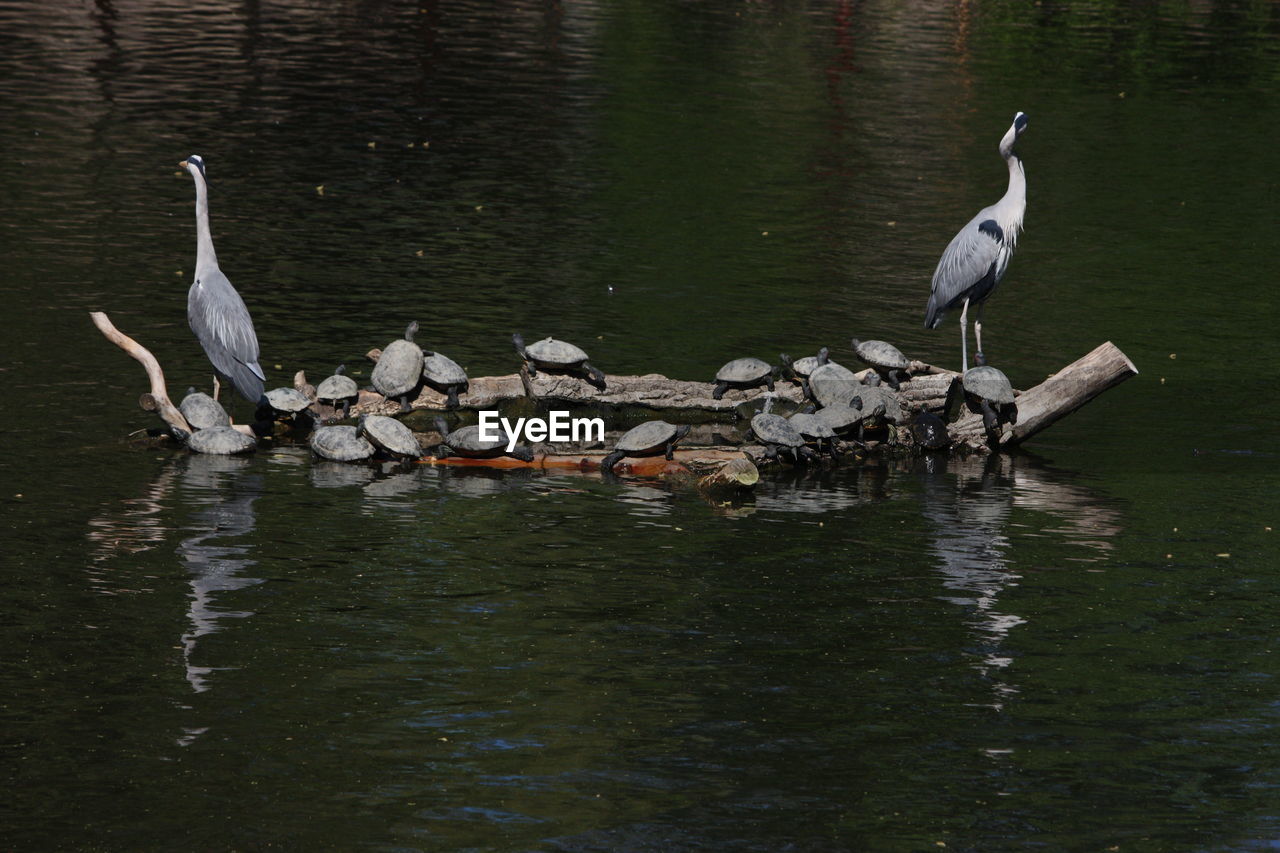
[0,0,1280,850]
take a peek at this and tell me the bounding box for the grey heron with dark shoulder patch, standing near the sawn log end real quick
[924,113,1027,370]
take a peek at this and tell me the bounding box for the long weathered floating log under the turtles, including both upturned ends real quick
[91,313,1138,466]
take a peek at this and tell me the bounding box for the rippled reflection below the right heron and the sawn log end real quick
[920,455,1120,711]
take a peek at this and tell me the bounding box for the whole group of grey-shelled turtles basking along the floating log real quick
[170,321,1018,471]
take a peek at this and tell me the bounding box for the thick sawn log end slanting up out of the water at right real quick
[951,341,1138,447]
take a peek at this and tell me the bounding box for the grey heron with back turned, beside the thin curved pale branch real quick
[178,154,266,403]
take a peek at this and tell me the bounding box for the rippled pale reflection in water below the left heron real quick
[178,455,262,693]
